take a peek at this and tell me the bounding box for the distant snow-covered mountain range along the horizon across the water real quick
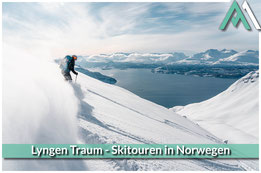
[78,49,259,66]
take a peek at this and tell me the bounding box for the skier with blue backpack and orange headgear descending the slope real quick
[60,55,78,81]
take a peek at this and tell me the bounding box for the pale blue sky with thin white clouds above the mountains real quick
[3,0,261,54]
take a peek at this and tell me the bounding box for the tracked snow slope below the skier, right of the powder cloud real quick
[73,73,258,170]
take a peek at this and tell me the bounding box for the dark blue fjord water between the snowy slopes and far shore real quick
[91,69,237,108]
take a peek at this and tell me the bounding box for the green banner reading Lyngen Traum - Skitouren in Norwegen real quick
[2,144,259,159]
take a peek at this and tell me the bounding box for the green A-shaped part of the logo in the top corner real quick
[219,1,251,30]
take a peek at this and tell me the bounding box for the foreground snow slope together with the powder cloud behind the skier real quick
[3,48,258,170]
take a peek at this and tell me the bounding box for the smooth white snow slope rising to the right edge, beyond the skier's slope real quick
[171,71,259,143]
